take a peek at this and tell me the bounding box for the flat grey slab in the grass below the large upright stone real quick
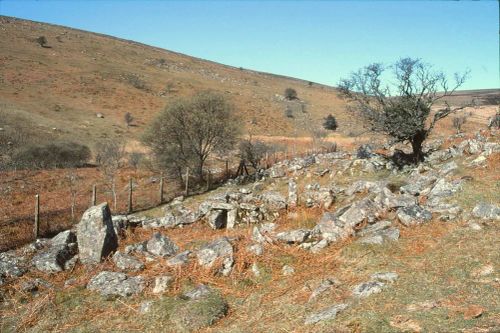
[87,271,144,297]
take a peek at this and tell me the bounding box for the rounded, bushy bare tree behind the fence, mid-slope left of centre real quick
[143,91,240,182]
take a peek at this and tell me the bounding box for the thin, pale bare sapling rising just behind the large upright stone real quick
[96,140,125,211]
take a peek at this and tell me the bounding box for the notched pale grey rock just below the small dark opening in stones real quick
[196,237,234,276]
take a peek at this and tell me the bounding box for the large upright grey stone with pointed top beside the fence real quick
[76,203,118,264]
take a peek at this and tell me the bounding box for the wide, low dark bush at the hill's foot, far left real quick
[12,142,90,169]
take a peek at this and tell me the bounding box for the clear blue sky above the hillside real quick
[0,0,500,89]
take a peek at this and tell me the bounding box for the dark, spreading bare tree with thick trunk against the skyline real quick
[339,58,468,163]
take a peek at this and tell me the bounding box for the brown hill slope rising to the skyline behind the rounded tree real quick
[0,16,352,148]
